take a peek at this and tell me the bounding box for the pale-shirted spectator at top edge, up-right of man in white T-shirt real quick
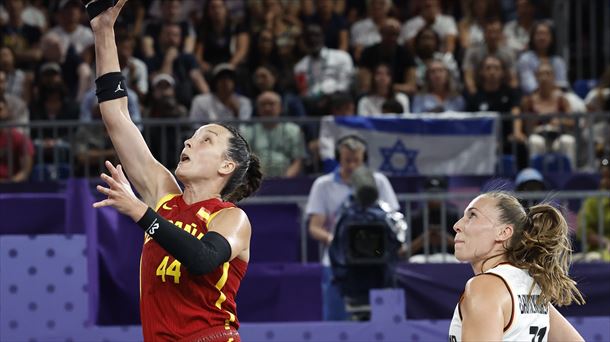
[350,0,388,63]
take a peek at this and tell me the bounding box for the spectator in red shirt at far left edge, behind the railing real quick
[0,95,34,183]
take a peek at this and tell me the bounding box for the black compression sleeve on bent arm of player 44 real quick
[138,208,231,275]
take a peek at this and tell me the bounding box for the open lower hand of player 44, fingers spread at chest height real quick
[93,161,148,222]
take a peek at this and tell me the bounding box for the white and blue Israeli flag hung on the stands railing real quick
[320,112,498,176]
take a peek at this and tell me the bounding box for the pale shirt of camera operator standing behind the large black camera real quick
[305,168,400,266]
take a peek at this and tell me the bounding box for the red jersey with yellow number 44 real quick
[140,195,248,341]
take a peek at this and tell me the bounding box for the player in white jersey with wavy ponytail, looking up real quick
[449,192,584,342]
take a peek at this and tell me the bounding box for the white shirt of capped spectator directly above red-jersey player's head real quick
[189,93,252,122]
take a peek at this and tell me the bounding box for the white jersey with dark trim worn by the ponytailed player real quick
[449,264,550,342]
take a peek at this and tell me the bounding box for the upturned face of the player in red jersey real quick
[176,124,231,182]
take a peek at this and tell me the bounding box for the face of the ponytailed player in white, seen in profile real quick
[453,195,500,264]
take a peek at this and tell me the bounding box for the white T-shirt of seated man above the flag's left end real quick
[294,47,354,96]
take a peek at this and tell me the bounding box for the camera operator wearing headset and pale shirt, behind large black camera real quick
[305,136,399,320]
